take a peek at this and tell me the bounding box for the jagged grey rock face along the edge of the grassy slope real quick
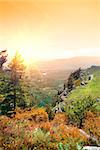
[58,65,100,101]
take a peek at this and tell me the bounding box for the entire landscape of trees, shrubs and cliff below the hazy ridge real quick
[0,50,100,150]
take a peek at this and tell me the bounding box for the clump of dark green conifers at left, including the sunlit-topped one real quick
[0,53,30,114]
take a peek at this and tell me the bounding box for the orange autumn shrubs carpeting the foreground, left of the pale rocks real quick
[0,108,87,150]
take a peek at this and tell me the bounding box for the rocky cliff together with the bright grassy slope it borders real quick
[53,66,100,113]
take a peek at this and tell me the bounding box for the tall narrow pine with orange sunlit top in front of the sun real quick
[9,52,25,109]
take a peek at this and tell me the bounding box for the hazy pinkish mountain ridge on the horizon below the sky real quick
[38,56,100,70]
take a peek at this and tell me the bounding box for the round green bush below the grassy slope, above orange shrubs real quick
[65,97,96,127]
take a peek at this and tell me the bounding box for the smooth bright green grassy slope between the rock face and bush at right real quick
[67,69,100,100]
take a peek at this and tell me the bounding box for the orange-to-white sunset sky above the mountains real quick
[0,0,100,61]
